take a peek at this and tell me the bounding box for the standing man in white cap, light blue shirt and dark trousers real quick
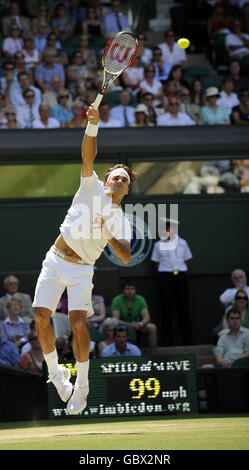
[151,218,193,346]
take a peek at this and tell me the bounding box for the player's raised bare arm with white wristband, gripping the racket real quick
[81,105,99,176]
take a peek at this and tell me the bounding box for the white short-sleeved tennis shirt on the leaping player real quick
[60,172,131,265]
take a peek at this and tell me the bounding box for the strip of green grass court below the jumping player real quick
[0,415,249,451]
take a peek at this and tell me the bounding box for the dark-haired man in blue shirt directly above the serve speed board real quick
[101,325,142,357]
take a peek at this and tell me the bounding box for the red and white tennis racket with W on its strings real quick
[94,31,138,109]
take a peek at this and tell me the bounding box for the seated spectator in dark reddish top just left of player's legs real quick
[20,331,44,372]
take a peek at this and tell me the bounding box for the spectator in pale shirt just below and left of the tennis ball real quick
[159,29,187,65]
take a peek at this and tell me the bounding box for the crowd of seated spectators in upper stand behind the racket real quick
[0,0,249,129]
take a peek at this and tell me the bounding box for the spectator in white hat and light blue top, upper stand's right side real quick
[201,86,231,126]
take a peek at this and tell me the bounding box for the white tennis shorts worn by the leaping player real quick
[33,251,94,317]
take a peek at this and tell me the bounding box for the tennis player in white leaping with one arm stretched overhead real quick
[33,104,136,415]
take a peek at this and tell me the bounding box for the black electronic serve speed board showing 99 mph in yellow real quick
[48,353,198,419]
